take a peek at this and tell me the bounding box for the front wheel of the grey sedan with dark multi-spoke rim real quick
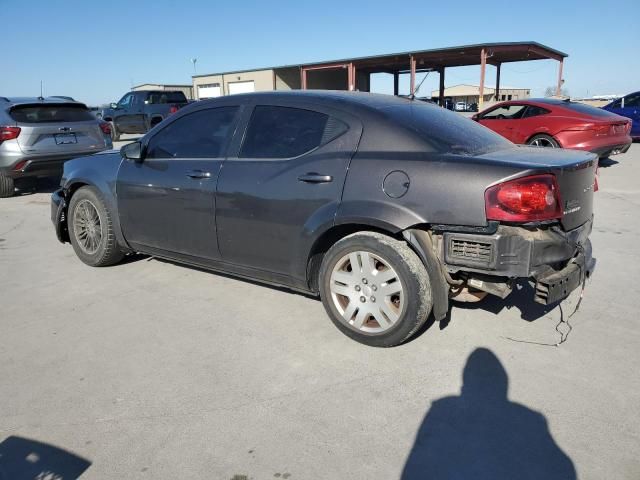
[67,186,124,267]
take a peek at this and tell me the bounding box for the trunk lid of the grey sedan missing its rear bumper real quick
[477,147,598,231]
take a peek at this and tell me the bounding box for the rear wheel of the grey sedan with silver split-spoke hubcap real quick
[319,232,433,347]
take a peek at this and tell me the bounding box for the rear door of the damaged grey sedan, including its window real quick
[216,101,362,279]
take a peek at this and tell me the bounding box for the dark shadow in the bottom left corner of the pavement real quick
[0,436,91,480]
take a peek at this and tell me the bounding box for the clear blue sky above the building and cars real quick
[0,0,640,104]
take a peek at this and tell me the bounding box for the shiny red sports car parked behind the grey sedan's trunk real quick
[472,98,632,158]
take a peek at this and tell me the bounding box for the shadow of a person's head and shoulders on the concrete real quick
[401,348,576,480]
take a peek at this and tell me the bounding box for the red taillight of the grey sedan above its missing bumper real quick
[484,174,562,222]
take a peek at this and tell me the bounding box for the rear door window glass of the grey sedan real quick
[240,105,348,158]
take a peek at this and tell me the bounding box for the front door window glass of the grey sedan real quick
[147,107,238,158]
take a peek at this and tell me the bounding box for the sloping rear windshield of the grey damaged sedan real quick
[383,101,511,155]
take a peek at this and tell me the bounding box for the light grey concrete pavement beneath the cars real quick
[0,143,640,480]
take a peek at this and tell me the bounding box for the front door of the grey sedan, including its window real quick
[116,105,239,260]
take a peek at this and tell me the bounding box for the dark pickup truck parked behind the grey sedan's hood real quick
[101,90,189,142]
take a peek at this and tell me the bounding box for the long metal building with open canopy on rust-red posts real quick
[192,42,568,107]
